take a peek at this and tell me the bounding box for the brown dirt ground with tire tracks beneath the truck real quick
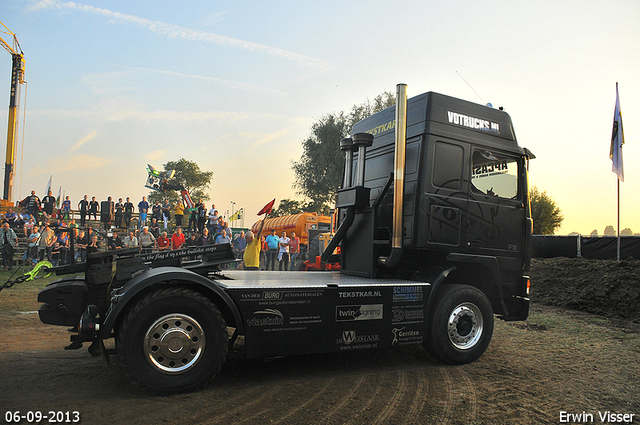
[0,261,640,425]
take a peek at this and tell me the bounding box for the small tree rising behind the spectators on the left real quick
[148,158,213,204]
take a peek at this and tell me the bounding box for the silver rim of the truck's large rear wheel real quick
[144,314,206,374]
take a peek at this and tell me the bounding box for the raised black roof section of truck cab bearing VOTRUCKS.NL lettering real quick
[352,92,524,153]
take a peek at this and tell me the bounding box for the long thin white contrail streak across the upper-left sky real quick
[28,0,335,71]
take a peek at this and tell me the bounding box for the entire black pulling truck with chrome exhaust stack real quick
[38,85,533,394]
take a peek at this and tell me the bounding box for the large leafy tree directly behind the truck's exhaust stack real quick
[292,92,395,213]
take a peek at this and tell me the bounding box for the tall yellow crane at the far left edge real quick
[0,22,25,207]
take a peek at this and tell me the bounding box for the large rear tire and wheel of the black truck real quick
[116,287,228,395]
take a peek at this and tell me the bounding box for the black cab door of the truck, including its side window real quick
[466,148,526,257]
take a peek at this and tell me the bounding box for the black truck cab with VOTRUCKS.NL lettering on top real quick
[338,88,533,320]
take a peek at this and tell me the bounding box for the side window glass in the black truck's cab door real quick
[471,150,519,199]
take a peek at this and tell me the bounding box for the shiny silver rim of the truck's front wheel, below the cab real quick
[447,303,484,350]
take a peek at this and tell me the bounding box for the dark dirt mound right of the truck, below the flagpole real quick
[531,258,640,323]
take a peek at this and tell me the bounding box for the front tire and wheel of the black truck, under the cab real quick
[425,284,493,364]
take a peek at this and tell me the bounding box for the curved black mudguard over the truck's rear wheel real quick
[101,267,244,338]
